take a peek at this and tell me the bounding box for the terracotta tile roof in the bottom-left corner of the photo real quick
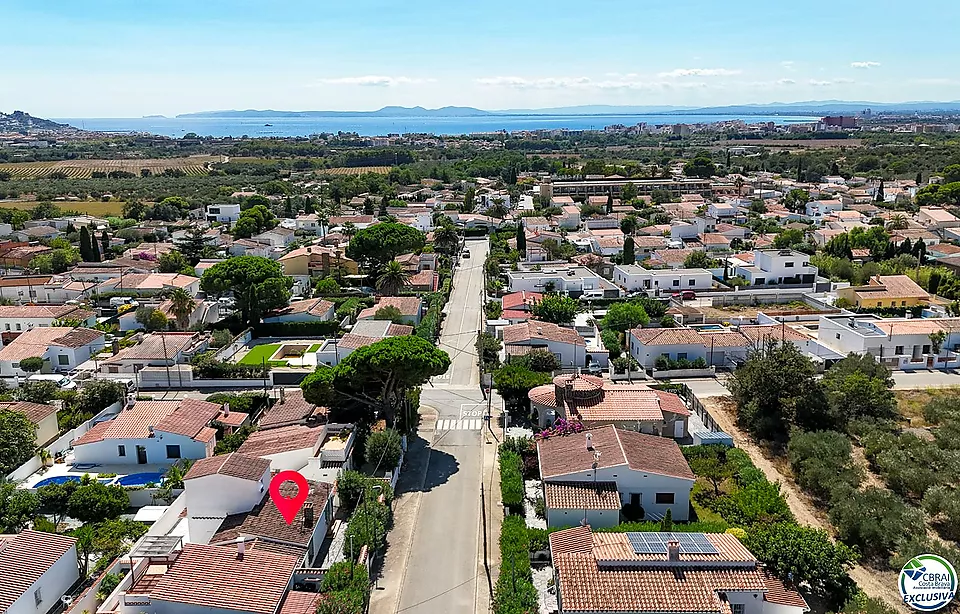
[0,529,77,612]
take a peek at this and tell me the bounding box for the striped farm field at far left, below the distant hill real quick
[0,156,220,179]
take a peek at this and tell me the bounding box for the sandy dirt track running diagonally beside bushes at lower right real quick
[701,397,910,612]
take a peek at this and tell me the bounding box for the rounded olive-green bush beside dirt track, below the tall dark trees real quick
[787,430,863,502]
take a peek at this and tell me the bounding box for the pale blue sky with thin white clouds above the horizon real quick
[7,0,960,118]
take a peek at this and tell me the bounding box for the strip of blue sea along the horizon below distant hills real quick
[54,114,819,138]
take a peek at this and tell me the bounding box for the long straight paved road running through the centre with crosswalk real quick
[371,241,493,614]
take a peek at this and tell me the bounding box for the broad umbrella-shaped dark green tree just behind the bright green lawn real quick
[200,256,293,324]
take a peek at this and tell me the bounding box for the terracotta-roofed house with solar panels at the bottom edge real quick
[549,525,810,614]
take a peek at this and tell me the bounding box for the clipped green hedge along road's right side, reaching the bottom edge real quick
[493,516,539,614]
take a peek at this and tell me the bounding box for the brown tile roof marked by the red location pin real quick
[210,481,333,546]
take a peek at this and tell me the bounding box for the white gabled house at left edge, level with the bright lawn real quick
[0,326,105,378]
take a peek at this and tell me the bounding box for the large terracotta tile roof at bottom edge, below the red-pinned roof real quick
[150,544,297,614]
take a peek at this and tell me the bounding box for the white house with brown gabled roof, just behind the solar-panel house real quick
[537,426,696,527]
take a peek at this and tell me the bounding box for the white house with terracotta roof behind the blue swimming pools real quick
[73,399,229,465]
